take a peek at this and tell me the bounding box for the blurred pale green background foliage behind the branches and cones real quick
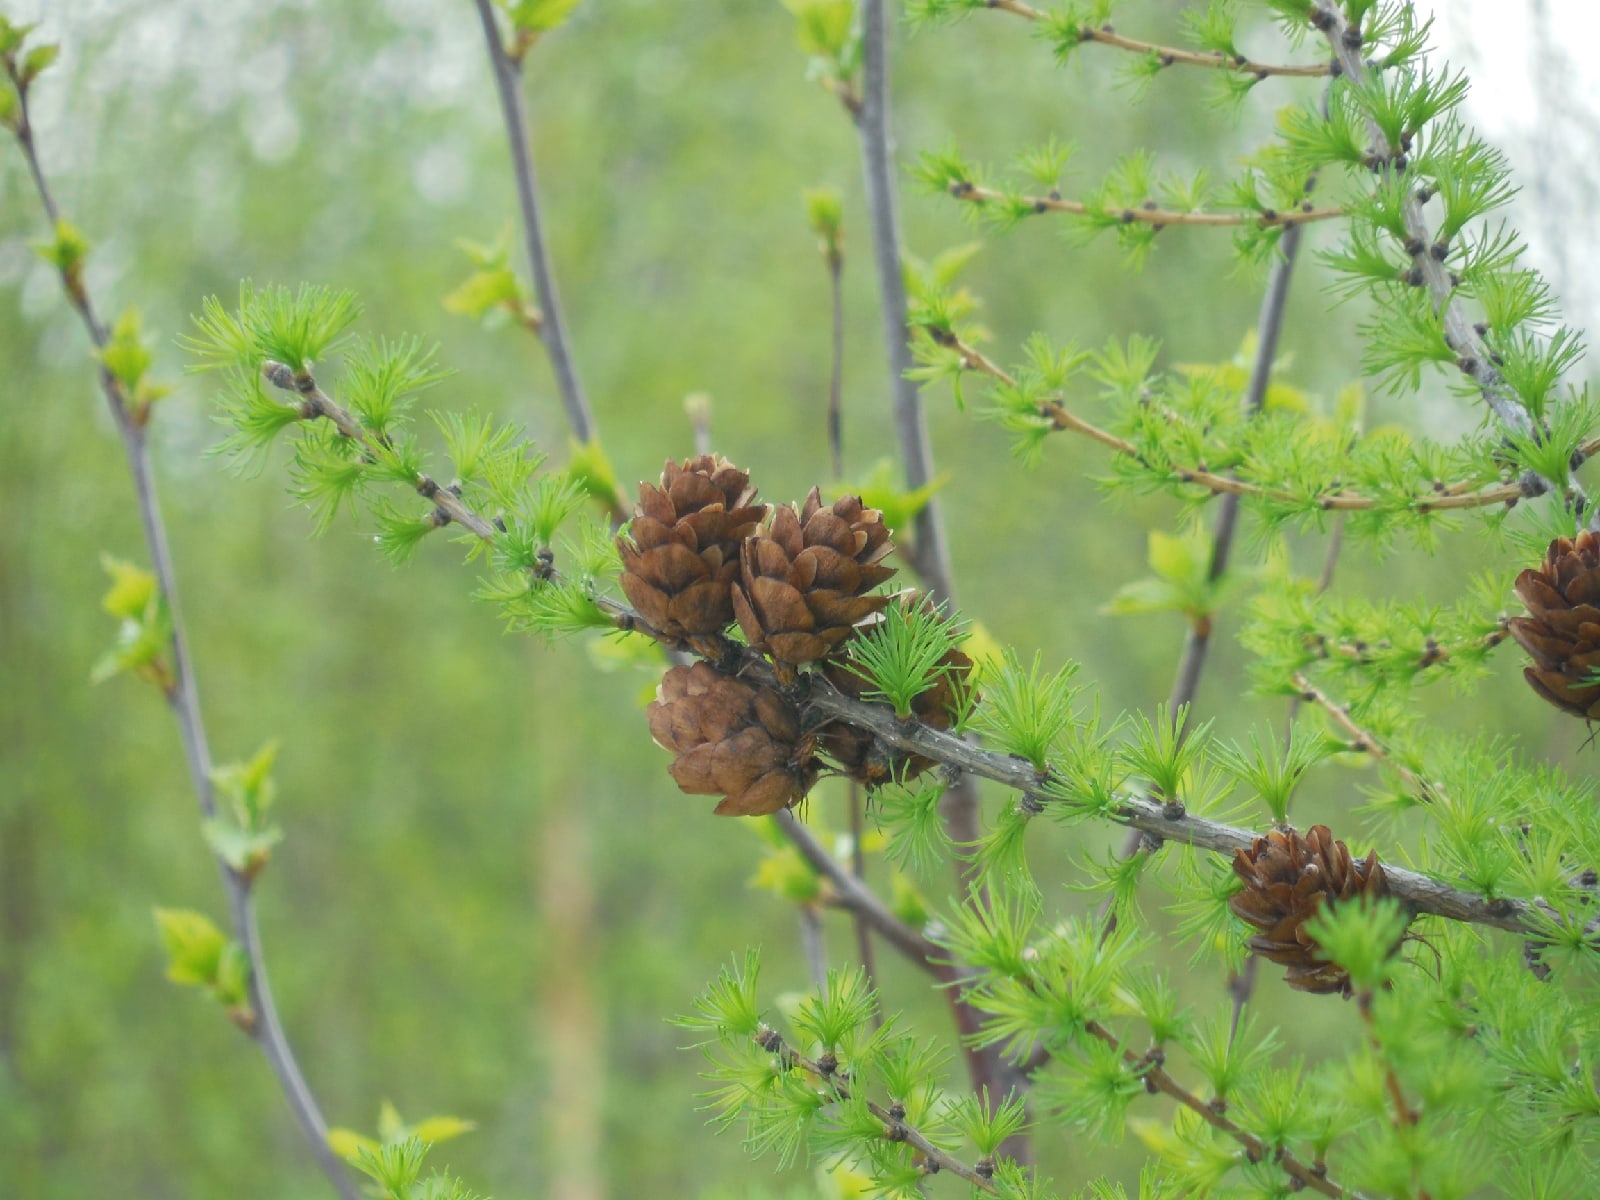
[0,0,1582,1200]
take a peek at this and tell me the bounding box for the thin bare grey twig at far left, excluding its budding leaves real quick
[7,77,360,1200]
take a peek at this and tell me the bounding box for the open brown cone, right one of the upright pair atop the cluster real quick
[733,488,894,678]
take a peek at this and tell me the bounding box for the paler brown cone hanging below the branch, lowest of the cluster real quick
[646,662,819,816]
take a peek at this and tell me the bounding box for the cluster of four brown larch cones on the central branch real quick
[618,454,971,816]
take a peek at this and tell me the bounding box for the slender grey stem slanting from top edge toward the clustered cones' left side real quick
[474,0,595,442]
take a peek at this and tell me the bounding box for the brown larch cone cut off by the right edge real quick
[1510,530,1600,720]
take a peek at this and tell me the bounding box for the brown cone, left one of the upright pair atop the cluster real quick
[616,454,766,642]
